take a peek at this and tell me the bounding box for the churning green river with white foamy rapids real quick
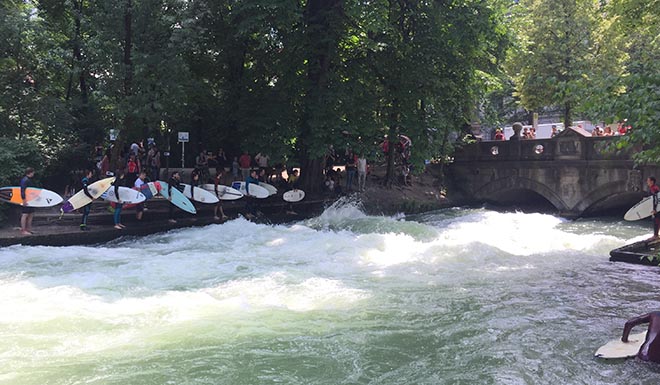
[0,203,660,385]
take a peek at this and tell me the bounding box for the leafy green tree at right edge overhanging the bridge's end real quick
[589,0,660,163]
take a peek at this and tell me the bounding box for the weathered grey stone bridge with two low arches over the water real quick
[449,129,660,218]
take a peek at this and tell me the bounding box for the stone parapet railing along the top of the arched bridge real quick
[454,136,631,162]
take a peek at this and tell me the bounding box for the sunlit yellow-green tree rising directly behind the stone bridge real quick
[509,0,607,127]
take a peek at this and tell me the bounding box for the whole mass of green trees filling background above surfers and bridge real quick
[0,0,660,191]
